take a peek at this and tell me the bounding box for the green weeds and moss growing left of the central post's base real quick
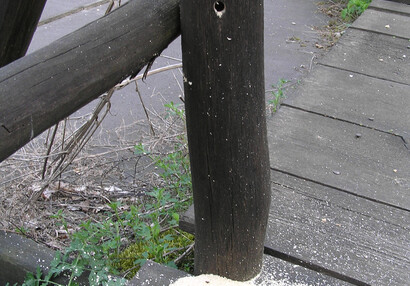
[18,102,194,286]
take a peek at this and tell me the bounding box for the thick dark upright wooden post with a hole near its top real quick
[181,0,270,281]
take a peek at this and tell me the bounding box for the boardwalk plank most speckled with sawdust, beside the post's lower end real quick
[265,172,410,286]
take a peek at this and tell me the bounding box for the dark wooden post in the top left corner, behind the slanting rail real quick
[0,0,46,67]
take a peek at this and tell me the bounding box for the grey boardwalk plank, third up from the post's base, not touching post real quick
[283,67,410,137]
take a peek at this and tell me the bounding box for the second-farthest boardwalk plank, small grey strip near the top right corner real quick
[352,9,410,40]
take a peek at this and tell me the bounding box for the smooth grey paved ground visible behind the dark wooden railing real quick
[28,0,328,130]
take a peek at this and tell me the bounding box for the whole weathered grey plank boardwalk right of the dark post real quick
[177,0,410,285]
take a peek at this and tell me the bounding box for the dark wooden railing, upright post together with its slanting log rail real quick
[0,0,270,280]
